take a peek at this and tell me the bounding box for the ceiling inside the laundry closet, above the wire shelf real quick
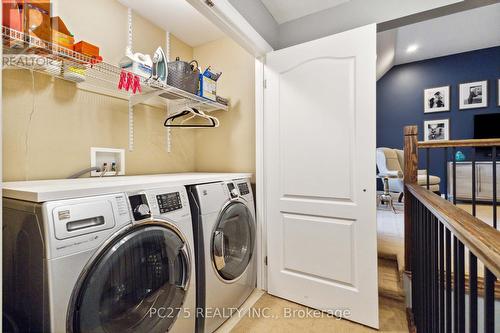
[118,0,224,47]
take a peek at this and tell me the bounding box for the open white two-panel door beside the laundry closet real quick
[264,25,378,328]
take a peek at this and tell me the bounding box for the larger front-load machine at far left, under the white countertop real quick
[3,186,196,333]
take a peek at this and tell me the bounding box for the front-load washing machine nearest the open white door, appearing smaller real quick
[188,179,257,333]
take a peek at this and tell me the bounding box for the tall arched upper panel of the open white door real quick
[279,58,354,199]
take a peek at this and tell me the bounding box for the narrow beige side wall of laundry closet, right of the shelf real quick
[193,38,255,179]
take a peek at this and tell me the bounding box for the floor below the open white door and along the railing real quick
[231,258,408,333]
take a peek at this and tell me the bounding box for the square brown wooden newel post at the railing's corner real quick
[403,126,418,272]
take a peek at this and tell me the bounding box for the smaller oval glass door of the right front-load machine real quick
[212,201,255,281]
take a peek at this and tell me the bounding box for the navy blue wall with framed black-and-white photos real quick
[377,47,500,192]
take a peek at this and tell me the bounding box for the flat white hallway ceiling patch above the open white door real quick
[261,0,350,24]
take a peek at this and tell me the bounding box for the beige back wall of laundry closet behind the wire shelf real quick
[2,0,195,181]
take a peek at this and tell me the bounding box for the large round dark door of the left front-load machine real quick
[68,224,190,333]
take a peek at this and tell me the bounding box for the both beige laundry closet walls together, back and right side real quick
[2,0,255,181]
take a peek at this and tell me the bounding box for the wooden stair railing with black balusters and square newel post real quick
[404,126,500,333]
